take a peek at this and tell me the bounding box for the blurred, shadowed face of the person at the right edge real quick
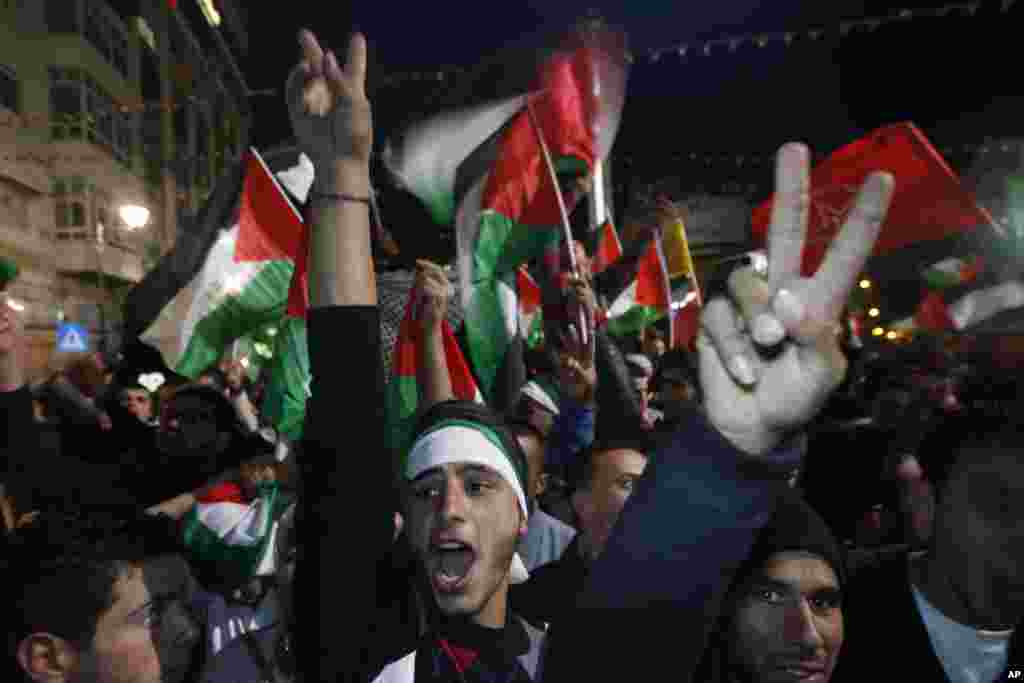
[932,450,1024,627]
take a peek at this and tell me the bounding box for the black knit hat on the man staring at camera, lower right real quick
[733,488,846,588]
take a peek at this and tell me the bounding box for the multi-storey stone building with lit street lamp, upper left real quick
[0,0,252,374]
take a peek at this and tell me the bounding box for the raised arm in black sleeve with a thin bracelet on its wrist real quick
[287,32,394,681]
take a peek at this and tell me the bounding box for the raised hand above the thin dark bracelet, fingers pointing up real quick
[286,31,373,185]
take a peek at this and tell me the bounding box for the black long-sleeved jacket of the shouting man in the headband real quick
[295,306,542,683]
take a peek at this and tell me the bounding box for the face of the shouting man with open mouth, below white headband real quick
[406,464,526,628]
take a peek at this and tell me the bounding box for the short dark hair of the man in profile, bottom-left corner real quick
[0,511,181,655]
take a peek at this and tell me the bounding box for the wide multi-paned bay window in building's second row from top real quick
[50,67,136,164]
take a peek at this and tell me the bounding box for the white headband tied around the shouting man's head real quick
[406,425,529,584]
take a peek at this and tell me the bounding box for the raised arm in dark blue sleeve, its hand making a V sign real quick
[546,145,893,681]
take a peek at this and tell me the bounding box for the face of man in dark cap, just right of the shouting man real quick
[575,449,647,559]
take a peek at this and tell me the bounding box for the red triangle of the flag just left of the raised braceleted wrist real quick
[234,150,309,317]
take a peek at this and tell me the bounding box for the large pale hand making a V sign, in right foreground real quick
[697,144,894,456]
